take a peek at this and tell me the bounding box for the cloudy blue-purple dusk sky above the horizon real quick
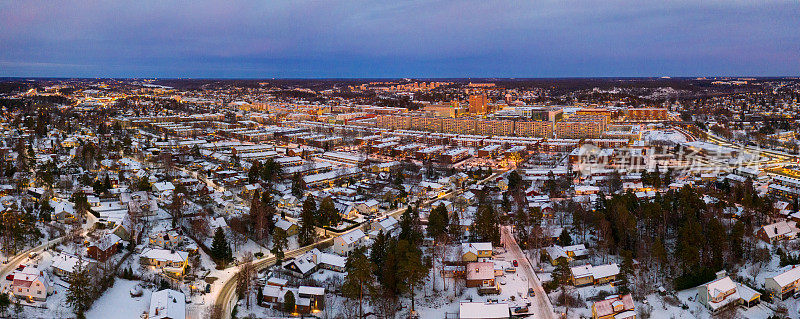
[0,0,800,78]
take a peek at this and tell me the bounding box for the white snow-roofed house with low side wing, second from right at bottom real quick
[697,271,761,313]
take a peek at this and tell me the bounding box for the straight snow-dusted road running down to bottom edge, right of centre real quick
[500,226,556,319]
